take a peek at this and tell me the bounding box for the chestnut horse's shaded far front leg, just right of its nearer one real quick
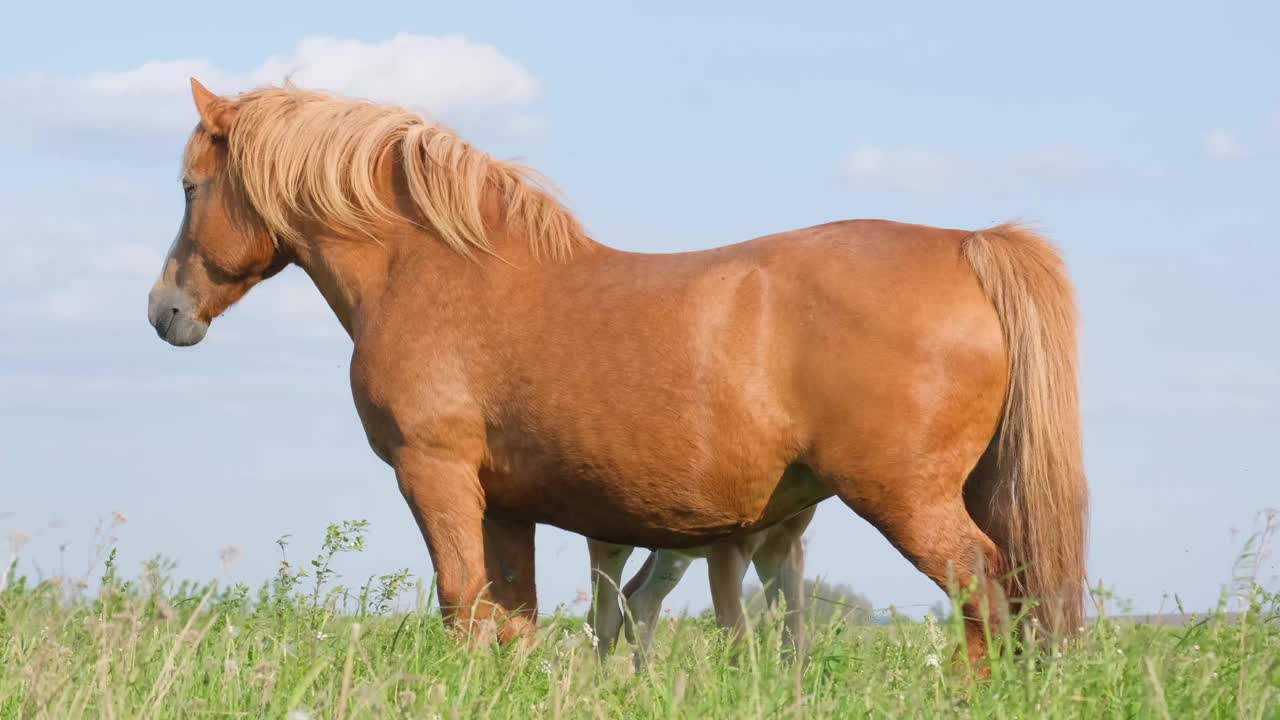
[483,514,538,641]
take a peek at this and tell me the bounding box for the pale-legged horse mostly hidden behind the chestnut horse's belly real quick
[586,506,817,670]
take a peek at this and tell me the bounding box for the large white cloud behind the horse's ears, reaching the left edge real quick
[0,33,541,135]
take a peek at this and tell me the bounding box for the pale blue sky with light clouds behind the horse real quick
[0,3,1280,610]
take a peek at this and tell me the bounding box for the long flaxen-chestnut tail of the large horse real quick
[963,224,1088,637]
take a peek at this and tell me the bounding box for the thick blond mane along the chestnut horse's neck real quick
[188,86,589,260]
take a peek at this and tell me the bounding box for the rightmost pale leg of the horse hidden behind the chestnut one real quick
[751,506,817,657]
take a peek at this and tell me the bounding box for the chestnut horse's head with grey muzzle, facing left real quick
[147,78,288,346]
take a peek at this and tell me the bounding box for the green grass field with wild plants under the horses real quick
[0,515,1280,719]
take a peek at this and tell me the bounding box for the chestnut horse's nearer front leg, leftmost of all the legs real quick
[394,448,524,641]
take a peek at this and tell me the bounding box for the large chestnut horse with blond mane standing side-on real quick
[148,81,1088,659]
